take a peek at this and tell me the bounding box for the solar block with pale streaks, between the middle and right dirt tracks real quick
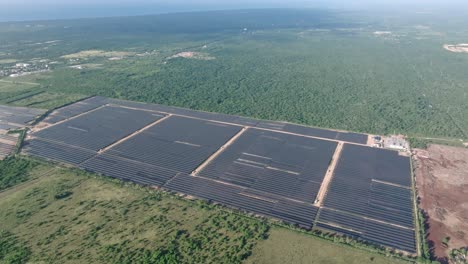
[199,129,337,203]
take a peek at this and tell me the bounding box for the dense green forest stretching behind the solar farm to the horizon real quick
[0,10,468,139]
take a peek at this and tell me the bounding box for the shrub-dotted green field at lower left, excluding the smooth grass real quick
[0,158,268,263]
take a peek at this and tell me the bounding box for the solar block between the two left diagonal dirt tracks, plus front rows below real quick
[82,116,241,186]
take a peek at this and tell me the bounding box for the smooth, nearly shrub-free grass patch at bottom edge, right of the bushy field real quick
[245,227,408,264]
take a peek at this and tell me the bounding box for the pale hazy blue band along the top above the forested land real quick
[0,0,468,21]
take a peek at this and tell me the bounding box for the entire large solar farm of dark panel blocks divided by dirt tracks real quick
[23,97,416,253]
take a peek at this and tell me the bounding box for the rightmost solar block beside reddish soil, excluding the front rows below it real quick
[324,144,414,227]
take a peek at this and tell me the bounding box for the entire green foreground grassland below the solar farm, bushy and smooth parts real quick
[0,158,414,263]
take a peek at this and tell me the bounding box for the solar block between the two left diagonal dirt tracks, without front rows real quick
[102,116,240,173]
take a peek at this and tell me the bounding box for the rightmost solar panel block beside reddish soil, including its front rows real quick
[319,144,416,252]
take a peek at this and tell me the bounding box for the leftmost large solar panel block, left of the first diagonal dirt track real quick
[24,106,163,165]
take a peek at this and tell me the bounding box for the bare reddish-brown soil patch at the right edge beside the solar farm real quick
[413,145,468,262]
